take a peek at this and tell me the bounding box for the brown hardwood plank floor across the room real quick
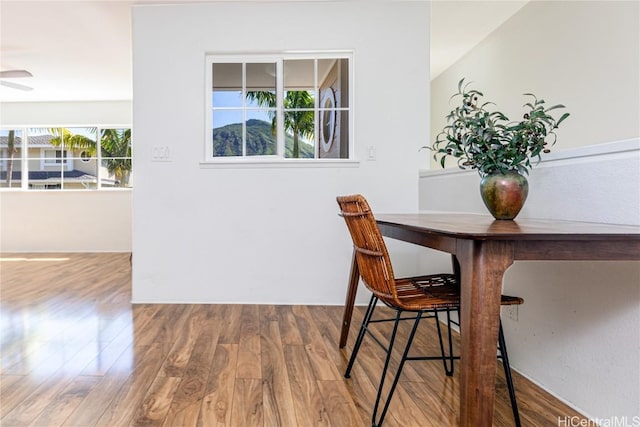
[0,254,586,427]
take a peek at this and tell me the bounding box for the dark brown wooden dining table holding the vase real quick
[340,213,640,427]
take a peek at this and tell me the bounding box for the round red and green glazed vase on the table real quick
[480,171,529,219]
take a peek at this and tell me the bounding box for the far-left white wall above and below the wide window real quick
[0,101,135,252]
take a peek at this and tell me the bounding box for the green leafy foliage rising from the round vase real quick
[423,79,569,176]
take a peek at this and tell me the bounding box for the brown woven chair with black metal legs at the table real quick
[337,195,523,426]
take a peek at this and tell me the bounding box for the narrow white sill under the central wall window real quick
[200,158,360,169]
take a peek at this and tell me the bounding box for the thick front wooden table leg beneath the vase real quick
[456,240,513,427]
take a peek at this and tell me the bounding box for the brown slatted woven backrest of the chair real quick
[336,194,398,303]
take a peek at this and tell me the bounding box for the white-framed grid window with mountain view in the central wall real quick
[205,52,353,162]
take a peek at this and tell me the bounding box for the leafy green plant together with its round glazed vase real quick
[423,78,569,219]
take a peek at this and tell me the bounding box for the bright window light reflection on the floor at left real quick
[0,304,134,377]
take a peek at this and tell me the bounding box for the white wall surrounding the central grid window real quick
[133,1,429,304]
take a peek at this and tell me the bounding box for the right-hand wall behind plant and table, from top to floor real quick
[420,1,640,420]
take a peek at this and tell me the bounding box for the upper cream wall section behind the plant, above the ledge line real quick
[430,0,640,155]
